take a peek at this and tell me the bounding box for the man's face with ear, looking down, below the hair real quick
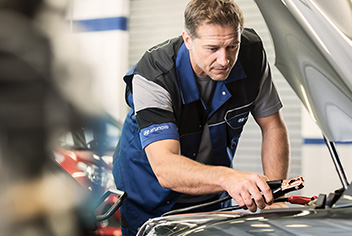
[182,24,241,81]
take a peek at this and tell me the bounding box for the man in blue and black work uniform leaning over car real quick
[113,0,289,235]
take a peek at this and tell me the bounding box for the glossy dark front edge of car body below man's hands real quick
[137,200,352,236]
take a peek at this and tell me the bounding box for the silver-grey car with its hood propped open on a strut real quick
[137,0,352,236]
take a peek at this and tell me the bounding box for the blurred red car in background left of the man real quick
[55,118,125,236]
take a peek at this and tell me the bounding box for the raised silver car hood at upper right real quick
[255,0,352,141]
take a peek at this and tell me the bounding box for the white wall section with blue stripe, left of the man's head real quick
[67,0,129,121]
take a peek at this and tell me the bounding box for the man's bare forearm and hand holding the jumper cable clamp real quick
[145,140,273,211]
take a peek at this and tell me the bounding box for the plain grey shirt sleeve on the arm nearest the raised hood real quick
[251,51,283,118]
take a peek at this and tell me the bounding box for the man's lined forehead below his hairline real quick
[197,24,241,43]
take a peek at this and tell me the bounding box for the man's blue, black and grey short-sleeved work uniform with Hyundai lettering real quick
[113,29,282,235]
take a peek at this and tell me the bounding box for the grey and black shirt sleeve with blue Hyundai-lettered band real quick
[132,75,179,148]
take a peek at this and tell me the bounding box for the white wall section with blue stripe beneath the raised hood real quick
[301,108,352,196]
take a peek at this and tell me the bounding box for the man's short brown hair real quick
[184,0,244,38]
